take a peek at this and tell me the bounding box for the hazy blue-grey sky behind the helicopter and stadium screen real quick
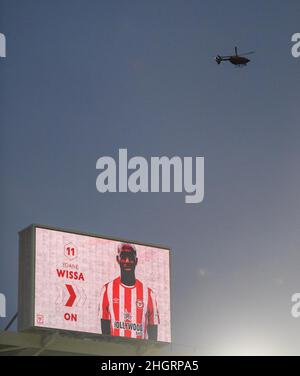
[0,0,300,354]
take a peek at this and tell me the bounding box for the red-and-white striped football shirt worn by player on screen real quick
[100,277,159,339]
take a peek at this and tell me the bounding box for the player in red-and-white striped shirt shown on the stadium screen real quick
[100,243,159,340]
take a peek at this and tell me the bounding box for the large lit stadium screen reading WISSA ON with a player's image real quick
[20,226,171,342]
